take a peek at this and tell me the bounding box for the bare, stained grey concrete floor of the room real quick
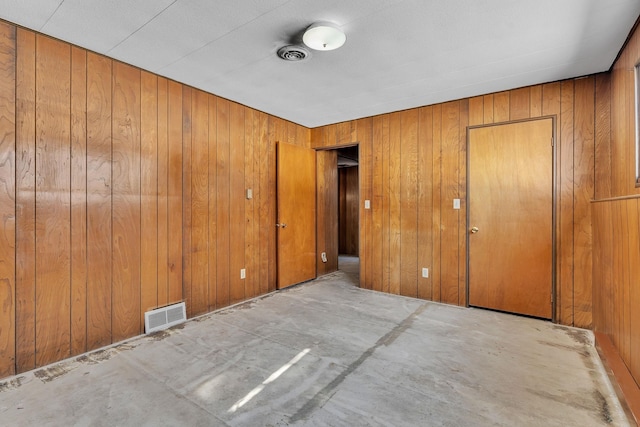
[0,263,629,426]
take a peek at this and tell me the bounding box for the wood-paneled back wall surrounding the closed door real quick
[311,78,609,327]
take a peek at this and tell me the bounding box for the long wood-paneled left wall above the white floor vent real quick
[0,23,309,377]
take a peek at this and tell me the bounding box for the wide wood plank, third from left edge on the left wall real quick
[35,35,71,366]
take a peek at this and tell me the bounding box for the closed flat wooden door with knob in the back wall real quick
[467,118,553,319]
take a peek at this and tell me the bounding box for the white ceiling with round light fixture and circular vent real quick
[0,0,640,127]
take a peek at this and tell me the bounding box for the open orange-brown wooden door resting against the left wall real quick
[276,142,316,289]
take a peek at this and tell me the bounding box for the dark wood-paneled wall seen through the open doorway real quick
[338,166,360,256]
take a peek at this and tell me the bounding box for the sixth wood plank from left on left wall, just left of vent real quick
[111,61,142,341]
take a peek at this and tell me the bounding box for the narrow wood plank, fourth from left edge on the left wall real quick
[71,47,87,355]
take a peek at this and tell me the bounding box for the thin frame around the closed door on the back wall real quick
[464,114,559,323]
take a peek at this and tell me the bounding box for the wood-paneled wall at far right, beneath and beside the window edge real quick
[592,20,640,402]
